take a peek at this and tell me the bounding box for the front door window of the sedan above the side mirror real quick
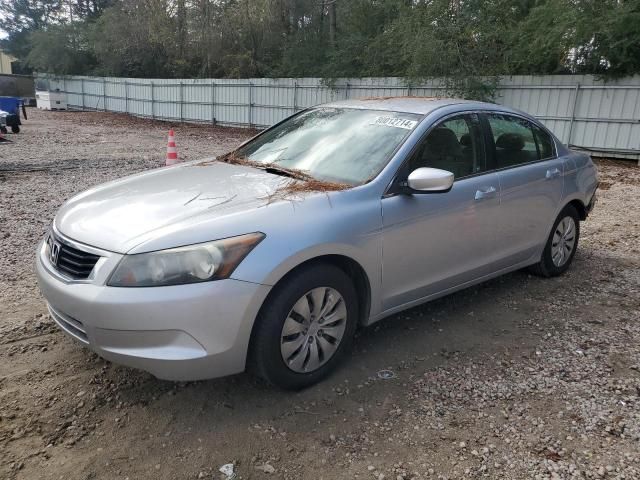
[409,115,485,179]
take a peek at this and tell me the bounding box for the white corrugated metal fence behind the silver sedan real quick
[38,75,640,160]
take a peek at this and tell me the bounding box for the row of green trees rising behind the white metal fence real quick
[0,0,640,99]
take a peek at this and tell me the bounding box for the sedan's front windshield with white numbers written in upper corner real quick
[236,107,420,185]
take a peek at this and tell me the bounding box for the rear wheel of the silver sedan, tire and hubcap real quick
[531,205,580,277]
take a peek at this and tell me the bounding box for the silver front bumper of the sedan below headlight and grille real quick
[36,238,271,380]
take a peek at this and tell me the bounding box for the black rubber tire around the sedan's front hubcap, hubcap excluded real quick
[247,263,359,390]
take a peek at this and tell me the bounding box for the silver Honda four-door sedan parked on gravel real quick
[37,98,598,389]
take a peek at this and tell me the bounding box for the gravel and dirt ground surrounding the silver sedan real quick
[0,109,640,480]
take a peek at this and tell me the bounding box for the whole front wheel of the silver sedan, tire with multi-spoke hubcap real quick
[249,264,358,390]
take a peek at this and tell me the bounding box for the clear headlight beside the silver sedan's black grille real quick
[107,232,265,287]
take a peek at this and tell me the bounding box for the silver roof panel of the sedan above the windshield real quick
[322,97,482,115]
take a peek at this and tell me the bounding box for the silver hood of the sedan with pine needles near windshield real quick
[55,160,286,253]
